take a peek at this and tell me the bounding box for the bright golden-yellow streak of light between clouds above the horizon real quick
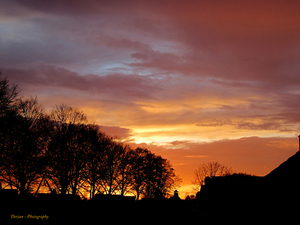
[123,122,293,145]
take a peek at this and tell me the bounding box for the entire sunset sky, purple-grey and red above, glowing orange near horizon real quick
[0,0,300,197]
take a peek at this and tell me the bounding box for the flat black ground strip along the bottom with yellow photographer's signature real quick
[0,194,300,224]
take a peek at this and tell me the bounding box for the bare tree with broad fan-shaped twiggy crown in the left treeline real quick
[46,104,87,194]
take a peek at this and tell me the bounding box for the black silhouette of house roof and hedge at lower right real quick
[197,136,300,222]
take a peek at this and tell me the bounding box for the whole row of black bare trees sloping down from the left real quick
[0,74,179,199]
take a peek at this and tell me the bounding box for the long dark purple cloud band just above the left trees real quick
[3,62,160,98]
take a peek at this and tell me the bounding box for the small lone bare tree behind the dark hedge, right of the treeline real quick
[192,162,232,191]
